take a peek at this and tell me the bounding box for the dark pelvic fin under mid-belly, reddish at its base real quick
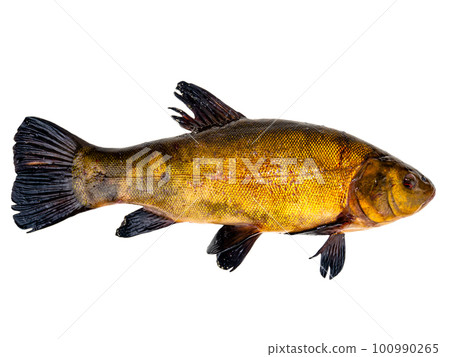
[206,225,261,271]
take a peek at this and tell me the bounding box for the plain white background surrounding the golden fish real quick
[0,0,450,356]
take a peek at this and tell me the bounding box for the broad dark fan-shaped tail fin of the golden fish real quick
[11,117,89,232]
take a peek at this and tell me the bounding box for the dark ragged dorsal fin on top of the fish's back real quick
[169,82,245,132]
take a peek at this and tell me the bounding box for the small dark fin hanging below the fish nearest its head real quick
[309,233,345,279]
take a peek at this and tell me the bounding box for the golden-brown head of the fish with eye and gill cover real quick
[354,156,436,224]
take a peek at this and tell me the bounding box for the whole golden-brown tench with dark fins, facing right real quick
[12,82,435,279]
